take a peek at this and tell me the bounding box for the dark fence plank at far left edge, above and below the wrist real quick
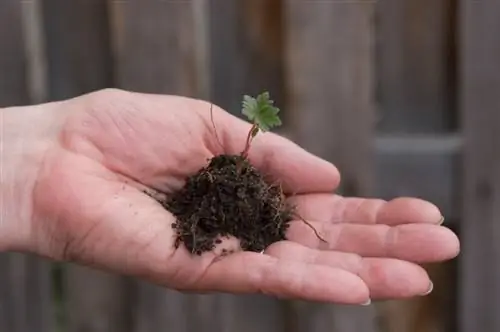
[0,0,53,332]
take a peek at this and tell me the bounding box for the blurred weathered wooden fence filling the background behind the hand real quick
[0,0,494,332]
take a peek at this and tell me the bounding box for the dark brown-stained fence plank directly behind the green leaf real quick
[205,0,288,332]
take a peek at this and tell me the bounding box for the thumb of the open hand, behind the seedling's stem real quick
[203,102,340,194]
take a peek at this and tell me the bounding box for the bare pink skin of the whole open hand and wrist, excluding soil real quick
[0,89,459,304]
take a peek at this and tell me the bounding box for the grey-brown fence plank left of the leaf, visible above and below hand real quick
[109,0,215,332]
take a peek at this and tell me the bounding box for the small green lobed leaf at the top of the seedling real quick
[241,92,281,131]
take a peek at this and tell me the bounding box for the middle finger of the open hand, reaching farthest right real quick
[287,221,459,263]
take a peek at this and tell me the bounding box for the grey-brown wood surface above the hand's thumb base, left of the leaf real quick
[109,0,199,96]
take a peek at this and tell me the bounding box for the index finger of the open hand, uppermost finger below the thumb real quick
[289,193,442,225]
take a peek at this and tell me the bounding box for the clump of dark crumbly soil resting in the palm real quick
[158,155,293,255]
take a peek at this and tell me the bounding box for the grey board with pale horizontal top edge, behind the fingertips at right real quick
[374,134,462,225]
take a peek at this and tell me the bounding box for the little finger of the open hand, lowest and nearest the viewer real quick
[200,252,369,304]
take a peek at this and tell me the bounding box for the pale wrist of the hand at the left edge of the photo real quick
[0,104,62,252]
